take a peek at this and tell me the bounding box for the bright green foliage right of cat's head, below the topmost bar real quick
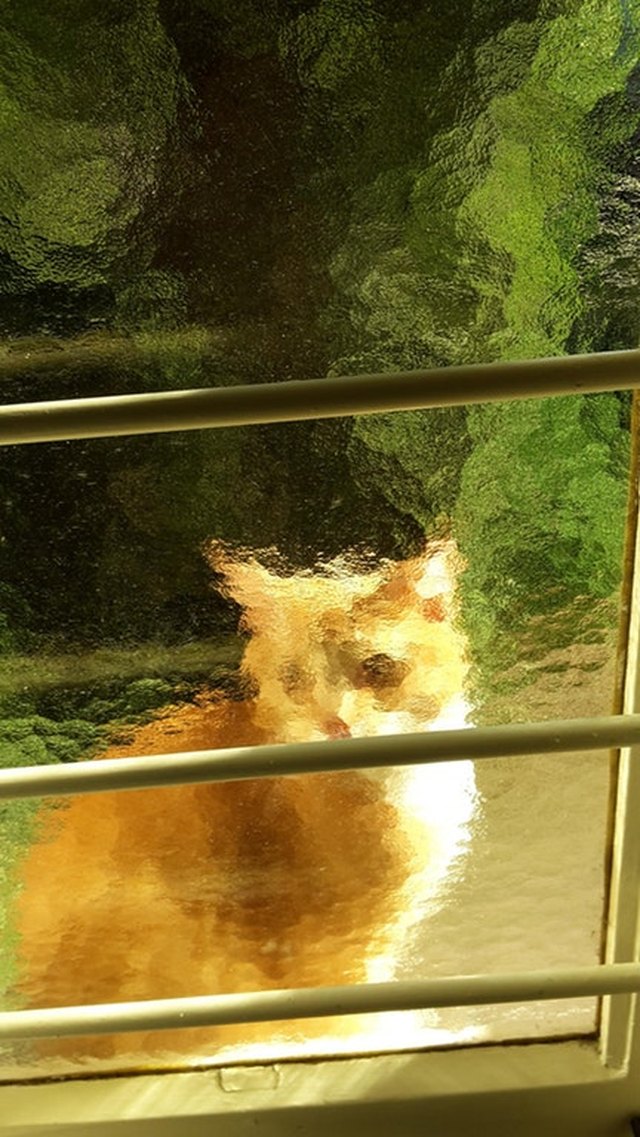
[455,395,629,695]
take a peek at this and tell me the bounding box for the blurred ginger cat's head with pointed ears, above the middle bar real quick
[207,542,466,741]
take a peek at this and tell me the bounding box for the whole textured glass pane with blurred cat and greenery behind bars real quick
[0,0,640,1079]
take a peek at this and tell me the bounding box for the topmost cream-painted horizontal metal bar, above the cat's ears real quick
[0,349,640,445]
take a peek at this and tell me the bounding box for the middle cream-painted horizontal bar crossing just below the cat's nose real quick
[0,715,640,799]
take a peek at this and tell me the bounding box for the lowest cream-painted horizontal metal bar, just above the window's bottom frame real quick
[0,963,640,1041]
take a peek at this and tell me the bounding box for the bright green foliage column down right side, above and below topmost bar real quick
[445,0,640,709]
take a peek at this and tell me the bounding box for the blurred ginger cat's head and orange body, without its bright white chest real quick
[10,542,466,1059]
